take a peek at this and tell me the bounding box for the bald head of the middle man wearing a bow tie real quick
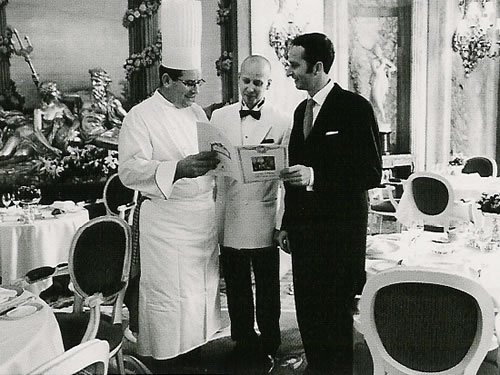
[239,55,271,109]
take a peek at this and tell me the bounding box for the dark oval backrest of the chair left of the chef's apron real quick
[69,216,131,308]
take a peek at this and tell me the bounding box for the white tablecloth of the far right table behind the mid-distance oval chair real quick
[396,173,500,225]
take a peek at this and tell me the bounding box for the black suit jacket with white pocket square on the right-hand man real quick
[282,84,382,294]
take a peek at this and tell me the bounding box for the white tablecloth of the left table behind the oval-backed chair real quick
[0,209,89,284]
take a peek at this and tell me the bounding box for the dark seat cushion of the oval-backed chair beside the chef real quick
[55,312,123,352]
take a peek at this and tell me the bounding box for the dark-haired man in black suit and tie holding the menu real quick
[277,33,382,374]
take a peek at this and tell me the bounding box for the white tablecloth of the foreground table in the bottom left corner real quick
[0,291,64,375]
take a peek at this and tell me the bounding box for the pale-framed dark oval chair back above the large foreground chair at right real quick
[405,172,455,228]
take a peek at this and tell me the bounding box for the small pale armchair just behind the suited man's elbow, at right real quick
[368,185,399,233]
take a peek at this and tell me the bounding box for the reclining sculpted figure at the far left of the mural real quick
[0,81,80,159]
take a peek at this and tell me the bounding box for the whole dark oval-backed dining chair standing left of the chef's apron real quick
[55,216,131,374]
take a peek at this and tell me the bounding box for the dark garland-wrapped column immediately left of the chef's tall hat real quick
[123,0,161,105]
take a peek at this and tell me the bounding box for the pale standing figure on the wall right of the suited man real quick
[370,43,396,125]
